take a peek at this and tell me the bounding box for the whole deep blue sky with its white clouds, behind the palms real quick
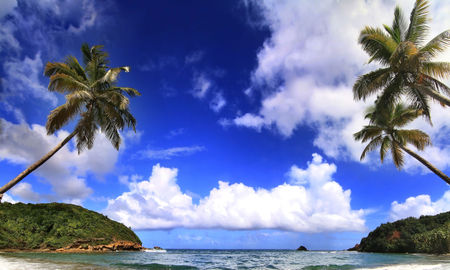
[0,0,450,249]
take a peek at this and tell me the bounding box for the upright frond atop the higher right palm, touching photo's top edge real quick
[405,0,429,45]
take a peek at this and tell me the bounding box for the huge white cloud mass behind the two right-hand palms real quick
[230,0,450,171]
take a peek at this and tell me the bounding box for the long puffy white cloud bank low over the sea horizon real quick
[104,154,365,232]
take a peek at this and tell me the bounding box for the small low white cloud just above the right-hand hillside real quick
[389,190,450,221]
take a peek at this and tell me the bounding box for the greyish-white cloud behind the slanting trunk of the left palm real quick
[0,119,118,204]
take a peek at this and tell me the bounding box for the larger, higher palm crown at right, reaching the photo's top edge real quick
[353,0,450,121]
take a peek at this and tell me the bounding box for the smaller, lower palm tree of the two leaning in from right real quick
[353,103,450,184]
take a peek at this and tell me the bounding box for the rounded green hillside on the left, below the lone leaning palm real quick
[0,203,141,249]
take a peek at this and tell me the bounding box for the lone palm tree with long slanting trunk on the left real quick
[0,43,140,202]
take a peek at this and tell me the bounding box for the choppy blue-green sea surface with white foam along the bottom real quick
[0,249,450,270]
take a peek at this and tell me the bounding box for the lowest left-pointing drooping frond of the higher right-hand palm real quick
[353,68,391,100]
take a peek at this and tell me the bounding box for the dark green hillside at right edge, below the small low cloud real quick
[356,212,450,254]
